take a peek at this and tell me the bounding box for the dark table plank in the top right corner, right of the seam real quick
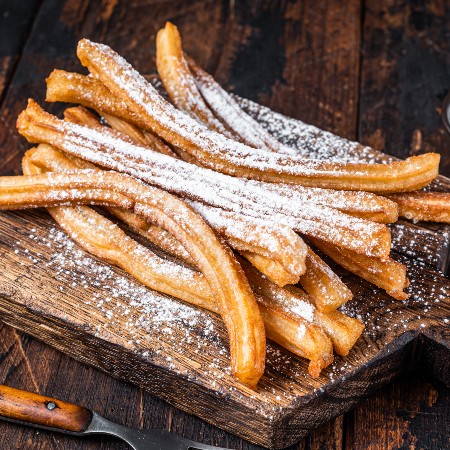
[359,0,450,176]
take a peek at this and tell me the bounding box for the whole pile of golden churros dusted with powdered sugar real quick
[0,23,450,389]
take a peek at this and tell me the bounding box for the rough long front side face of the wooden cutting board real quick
[0,290,274,446]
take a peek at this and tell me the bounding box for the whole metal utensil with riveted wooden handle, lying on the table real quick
[0,385,234,450]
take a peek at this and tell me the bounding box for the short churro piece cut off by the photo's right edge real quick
[389,191,450,223]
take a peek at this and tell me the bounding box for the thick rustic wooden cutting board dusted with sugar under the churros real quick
[0,99,450,448]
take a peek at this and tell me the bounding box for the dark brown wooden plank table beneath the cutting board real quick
[0,0,450,450]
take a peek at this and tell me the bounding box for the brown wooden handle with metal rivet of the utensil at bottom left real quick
[0,385,92,432]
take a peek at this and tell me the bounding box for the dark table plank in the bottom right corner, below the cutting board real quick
[344,374,450,450]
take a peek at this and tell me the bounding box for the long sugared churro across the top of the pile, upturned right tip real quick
[77,39,440,193]
